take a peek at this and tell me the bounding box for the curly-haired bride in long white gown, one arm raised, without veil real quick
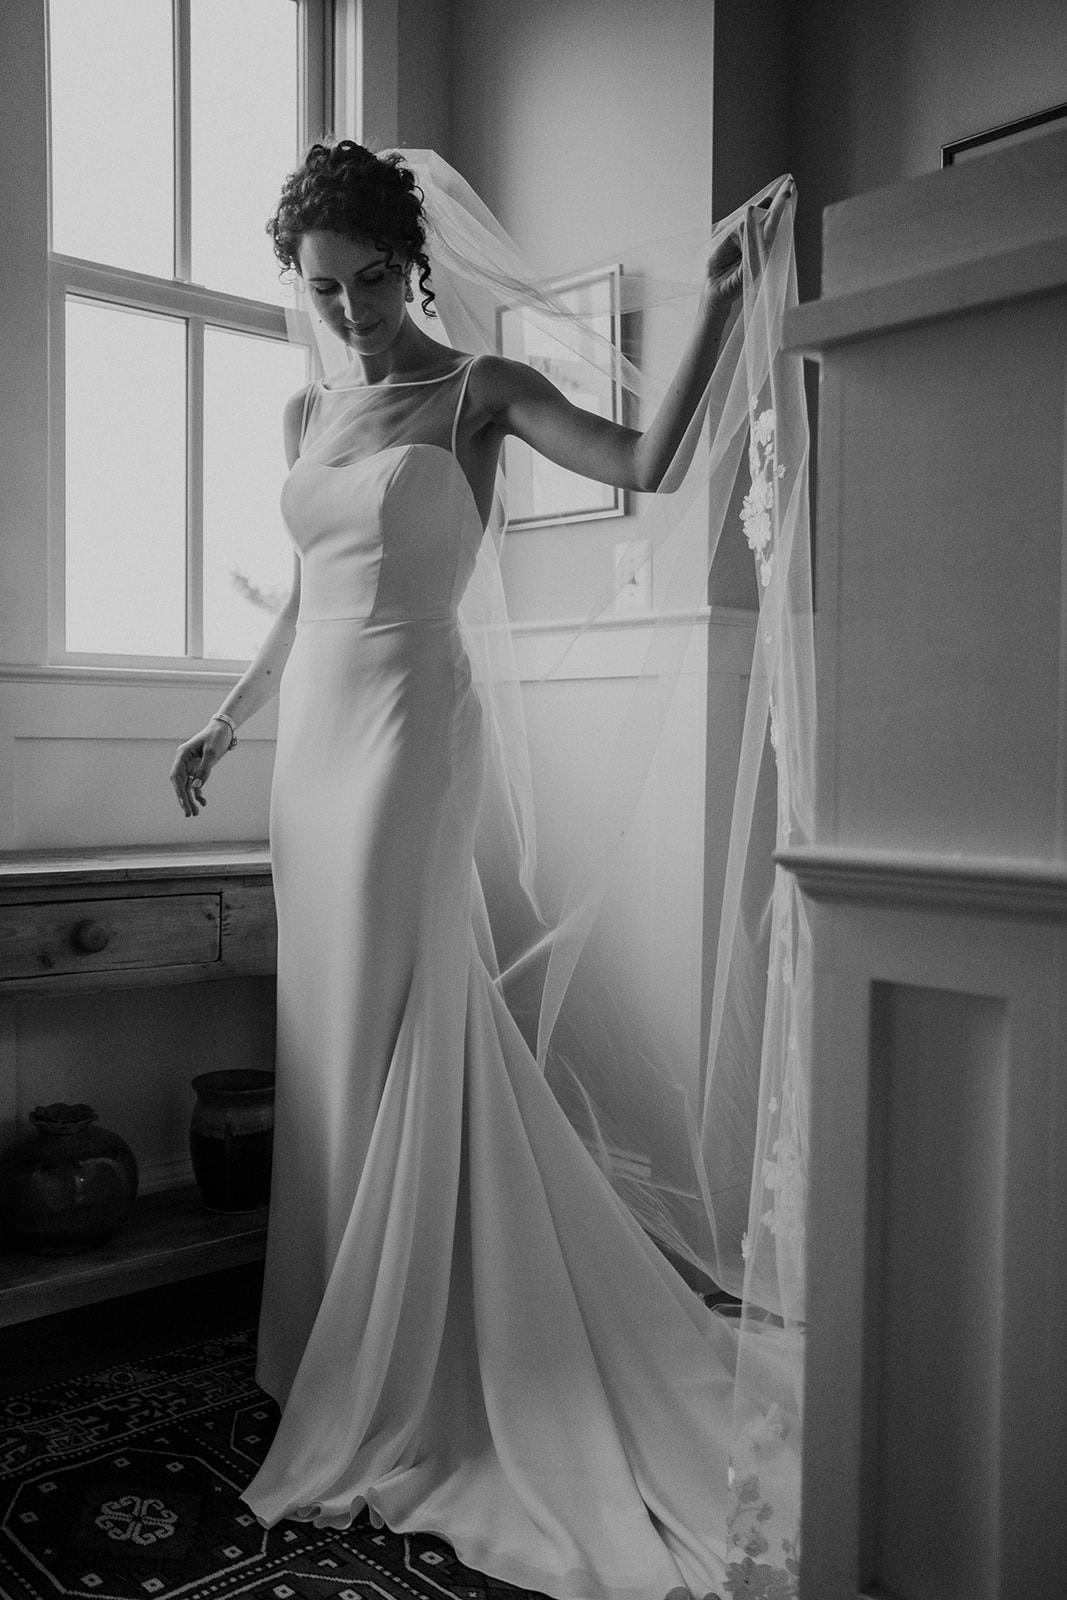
[171,141,790,1600]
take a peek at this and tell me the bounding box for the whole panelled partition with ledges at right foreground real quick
[779,134,1067,1600]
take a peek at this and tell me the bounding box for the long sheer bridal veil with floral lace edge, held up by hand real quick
[283,150,814,1600]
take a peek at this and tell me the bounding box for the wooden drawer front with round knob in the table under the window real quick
[0,893,219,982]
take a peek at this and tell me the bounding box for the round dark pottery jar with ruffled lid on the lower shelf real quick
[0,1101,138,1256]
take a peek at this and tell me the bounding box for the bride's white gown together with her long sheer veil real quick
[245,140,814,1600]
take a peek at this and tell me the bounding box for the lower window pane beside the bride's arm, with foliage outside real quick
[203,328,307,661]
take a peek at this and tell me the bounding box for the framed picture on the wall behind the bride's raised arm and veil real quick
[496,267,627,528]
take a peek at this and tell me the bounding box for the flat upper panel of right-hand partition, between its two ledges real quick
[819,294,1067,856]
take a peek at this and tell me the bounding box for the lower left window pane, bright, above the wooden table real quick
[66,298,186,656]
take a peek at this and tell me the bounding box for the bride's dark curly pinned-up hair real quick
[267,139,437,317]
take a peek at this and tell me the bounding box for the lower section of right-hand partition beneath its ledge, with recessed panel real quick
[800,902,1067,1600]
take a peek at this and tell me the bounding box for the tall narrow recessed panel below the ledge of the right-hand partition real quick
[867,982,1009,1600]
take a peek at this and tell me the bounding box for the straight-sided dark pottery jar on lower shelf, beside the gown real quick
[189,1069,274,1211]
